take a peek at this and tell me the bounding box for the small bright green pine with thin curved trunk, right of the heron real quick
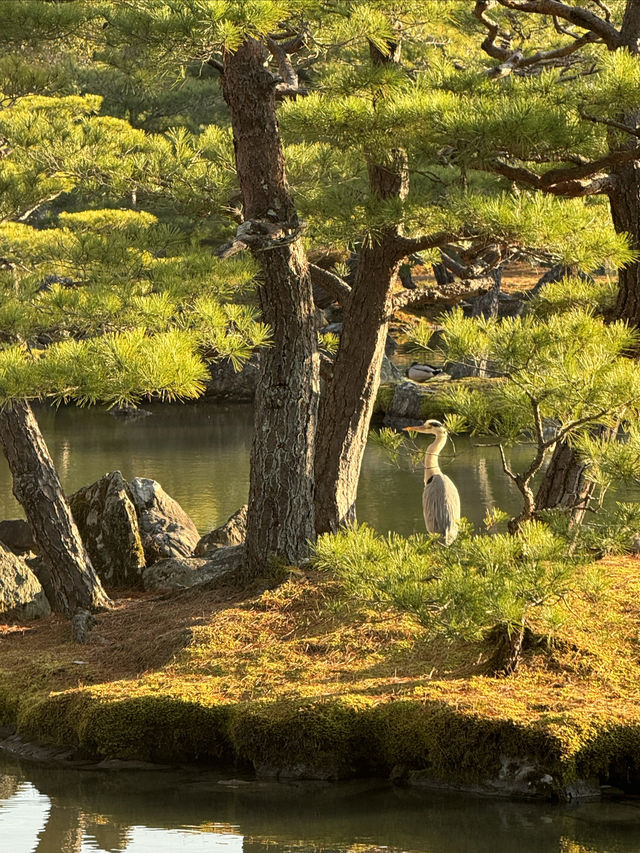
[414,308,640,529]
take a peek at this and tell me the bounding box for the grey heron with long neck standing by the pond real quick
[404,420,460,545]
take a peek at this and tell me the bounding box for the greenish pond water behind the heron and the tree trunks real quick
[0,403,620,535]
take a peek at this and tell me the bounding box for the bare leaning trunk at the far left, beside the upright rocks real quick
[0,401,111,617]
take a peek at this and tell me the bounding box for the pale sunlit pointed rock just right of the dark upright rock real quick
[129,477,200,565]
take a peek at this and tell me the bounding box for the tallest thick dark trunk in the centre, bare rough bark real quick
[223,39,319,579]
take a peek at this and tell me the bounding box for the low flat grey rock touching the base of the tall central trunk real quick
[142,545,244,591]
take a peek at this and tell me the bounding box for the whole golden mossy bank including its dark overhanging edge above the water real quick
[0,557,640,790]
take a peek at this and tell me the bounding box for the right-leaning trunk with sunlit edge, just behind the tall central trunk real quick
[315,150,408,533]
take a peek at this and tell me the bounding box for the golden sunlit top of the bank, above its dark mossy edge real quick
[0,558,640,723]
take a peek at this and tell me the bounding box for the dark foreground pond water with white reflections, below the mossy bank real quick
[0,752,640,853]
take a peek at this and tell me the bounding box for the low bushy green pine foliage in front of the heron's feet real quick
[314,522,585,640]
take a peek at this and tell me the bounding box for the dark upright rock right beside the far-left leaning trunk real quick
[69,471,145,586]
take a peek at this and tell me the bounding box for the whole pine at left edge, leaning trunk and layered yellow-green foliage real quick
[0,18,266,604]
